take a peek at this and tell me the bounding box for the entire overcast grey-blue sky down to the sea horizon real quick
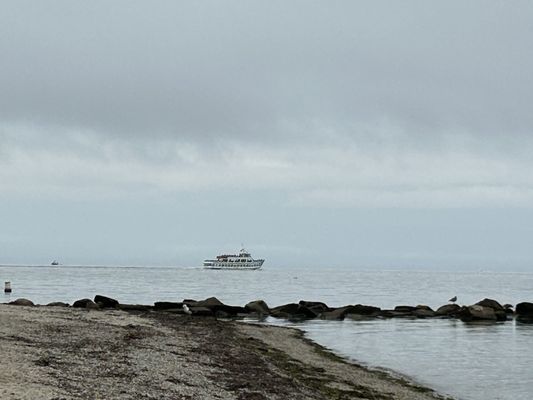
[0,0,533,270]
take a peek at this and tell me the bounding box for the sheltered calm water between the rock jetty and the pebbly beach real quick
[269,319,533,400]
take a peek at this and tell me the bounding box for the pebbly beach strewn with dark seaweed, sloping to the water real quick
[0,304,450,400]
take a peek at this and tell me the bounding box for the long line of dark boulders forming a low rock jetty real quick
[8,295,533,323]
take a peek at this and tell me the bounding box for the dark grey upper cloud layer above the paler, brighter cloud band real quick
[0,1,533,141]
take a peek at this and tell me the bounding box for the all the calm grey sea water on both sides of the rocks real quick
[0,266,533,400]
